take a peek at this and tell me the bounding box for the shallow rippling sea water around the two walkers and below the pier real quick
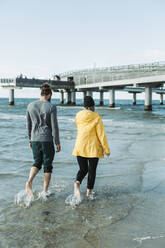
[0,98,165,248]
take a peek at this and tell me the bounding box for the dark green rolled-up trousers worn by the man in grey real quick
[32,141,55,173]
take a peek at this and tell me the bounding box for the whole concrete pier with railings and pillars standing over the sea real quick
[0,62,165,111]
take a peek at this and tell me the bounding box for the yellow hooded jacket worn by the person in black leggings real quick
[72,109,110,158]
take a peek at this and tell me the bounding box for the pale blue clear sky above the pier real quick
[0,0,165,97]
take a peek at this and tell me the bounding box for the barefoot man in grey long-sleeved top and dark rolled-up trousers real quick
[26,83,61,196]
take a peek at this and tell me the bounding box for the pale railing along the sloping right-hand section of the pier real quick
[60,61,165,85]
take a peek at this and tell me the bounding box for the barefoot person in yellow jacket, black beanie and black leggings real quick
[72,96,110,198]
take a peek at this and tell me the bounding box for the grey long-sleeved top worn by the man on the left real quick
[27,100,60,145]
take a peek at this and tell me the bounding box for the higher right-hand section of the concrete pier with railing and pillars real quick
[60,62,165,110]
